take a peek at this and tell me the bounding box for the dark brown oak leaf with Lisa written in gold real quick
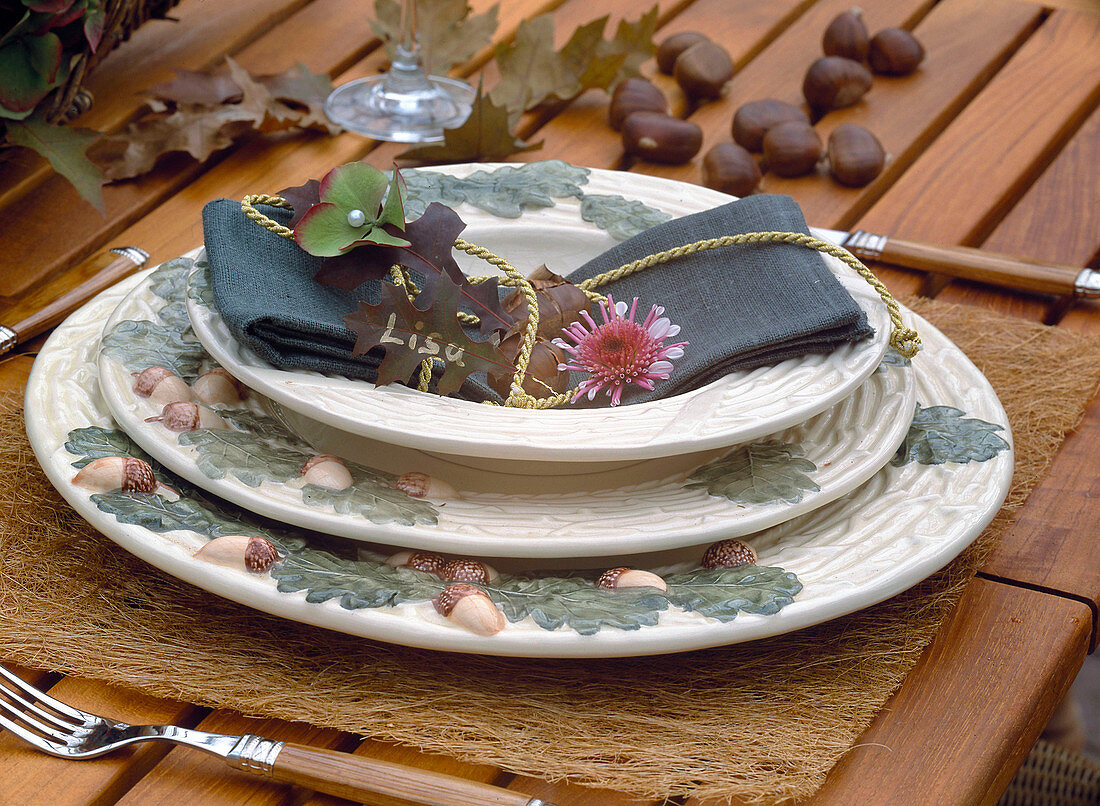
[344,275,515,395]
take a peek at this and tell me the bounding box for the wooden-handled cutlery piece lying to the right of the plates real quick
[813,228,1100,299]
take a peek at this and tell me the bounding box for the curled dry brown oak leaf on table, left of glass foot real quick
[92,57,340,180]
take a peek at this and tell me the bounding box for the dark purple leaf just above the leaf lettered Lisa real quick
[316,202,513,334]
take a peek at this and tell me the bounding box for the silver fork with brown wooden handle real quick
[0,665,550,806]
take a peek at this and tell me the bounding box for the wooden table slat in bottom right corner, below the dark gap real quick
[810,579,1091,806]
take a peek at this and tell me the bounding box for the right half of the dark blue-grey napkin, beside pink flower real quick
[568,195,873,402]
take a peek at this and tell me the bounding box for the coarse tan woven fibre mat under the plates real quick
[0,300,1100,803]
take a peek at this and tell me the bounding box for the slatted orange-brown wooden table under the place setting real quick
[0,0,1100,806]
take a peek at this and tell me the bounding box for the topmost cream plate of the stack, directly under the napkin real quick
[188,164,890,462]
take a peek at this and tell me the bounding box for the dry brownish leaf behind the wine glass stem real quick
[371,0,499,75]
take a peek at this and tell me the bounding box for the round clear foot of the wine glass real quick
[325,74,475,143]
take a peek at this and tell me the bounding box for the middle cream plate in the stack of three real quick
[99,261,915,557]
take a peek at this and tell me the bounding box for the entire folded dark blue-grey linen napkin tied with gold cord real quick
[202,196,871,404]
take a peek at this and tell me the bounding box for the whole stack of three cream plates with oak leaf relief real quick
[28,165,1012,656]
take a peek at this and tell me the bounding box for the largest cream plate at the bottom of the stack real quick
[26,273,1012,658]
